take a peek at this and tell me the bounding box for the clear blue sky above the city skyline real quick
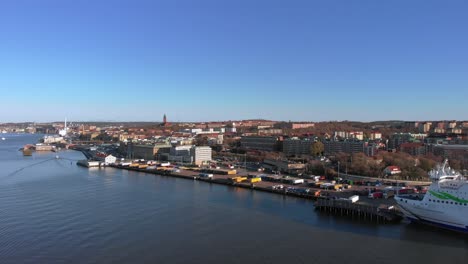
[0,0,468,122]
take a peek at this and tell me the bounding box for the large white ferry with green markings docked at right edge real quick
[395,160,468,233]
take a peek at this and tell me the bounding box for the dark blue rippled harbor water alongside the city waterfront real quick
[0,134,468,264]
